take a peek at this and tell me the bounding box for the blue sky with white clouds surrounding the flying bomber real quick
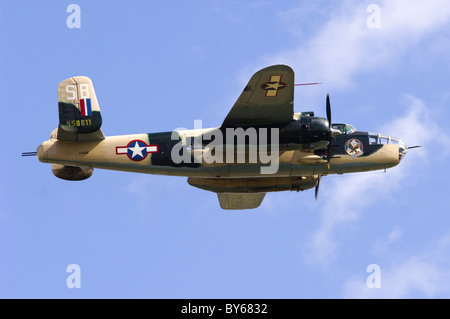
[0,0,450,298]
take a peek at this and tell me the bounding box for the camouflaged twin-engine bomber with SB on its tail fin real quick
[29,65,414,209]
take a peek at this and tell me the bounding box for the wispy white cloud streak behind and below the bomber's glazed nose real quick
[305,96,450,267]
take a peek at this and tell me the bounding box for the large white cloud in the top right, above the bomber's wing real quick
[250,0,450,95]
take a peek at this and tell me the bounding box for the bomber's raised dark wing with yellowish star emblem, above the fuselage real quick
[222,64,294,127]
